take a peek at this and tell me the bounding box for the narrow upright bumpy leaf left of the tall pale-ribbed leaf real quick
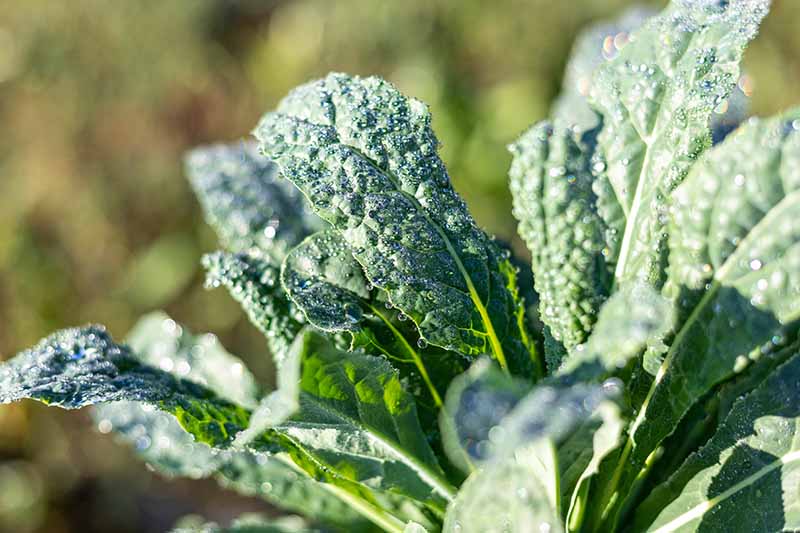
[510,123,613,371]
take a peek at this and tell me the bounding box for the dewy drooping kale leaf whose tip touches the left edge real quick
[0,326,249,446]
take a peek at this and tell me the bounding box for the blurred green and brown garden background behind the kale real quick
[0,0,800,533]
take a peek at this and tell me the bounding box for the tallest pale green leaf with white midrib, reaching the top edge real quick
[590,0,769,285]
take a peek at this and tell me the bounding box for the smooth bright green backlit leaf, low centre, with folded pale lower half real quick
[274,330,454,510]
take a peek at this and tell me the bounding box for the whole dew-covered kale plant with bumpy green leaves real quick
[0,0,800,533]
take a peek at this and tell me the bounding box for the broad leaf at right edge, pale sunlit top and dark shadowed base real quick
[592,106,800,524]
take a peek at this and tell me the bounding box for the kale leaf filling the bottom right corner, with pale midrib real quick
[636,355,800,533]
